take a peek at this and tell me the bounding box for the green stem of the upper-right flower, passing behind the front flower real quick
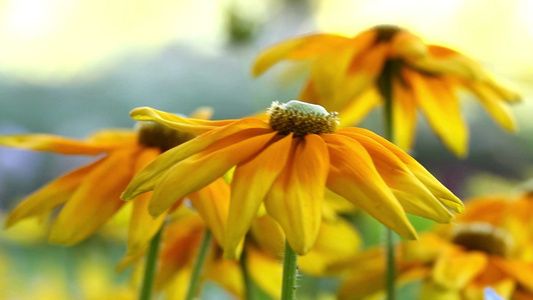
[378,60,398,300]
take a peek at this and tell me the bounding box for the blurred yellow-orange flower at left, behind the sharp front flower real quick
[0,109,216,251]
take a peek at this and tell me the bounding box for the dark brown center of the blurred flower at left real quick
[137,121,195,152]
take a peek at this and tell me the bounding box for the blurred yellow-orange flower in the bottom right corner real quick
[339,199,533,300]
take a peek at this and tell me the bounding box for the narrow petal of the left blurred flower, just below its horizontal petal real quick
[6,159,105,227]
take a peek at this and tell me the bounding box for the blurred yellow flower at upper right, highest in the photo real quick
[253,26,519,156]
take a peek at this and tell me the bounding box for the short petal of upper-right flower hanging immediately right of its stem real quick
[392,79,416,151]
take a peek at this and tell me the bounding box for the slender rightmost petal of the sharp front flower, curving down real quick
[337,127,464,213]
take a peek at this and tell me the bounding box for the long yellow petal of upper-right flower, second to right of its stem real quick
[403,69,468,157]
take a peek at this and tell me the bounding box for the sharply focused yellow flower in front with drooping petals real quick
[123,100,463,257]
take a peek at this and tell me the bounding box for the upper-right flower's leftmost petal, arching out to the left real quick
[252,34,350,76]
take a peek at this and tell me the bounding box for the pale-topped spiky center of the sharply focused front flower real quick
[268,100,339,137]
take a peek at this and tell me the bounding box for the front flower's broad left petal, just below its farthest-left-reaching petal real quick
[149,128,277,216]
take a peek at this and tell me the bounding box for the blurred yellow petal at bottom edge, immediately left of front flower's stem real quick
[246,246,283,299]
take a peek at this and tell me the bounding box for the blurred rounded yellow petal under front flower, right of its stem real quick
[298,218,362,276]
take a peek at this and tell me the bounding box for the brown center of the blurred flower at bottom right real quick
[452,223,513,256]
